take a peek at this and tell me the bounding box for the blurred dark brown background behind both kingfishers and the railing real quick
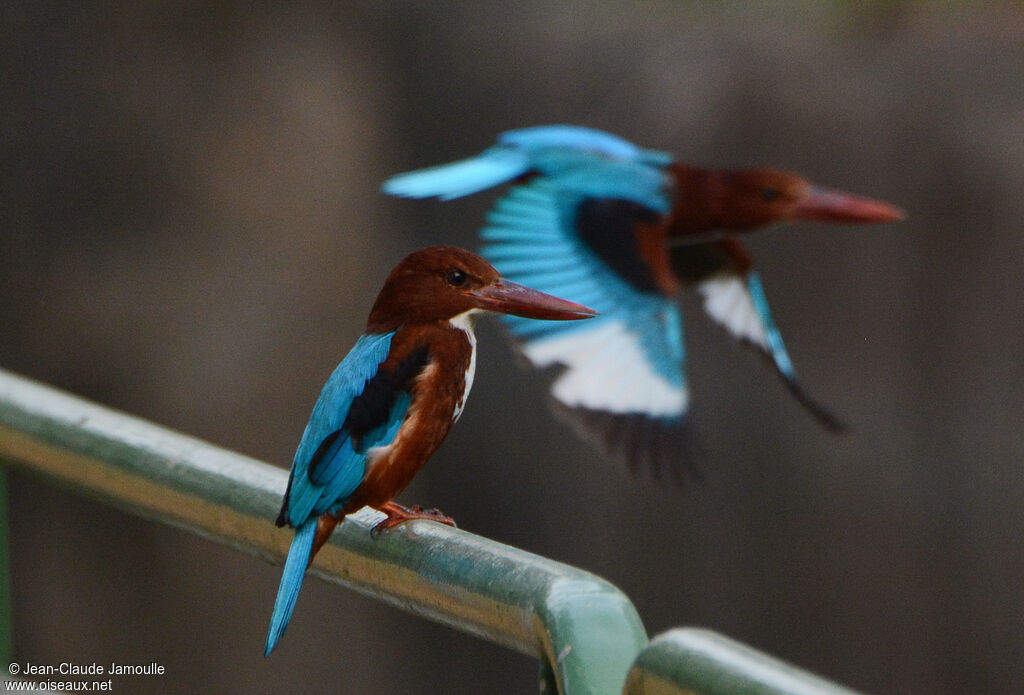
[0,0,1024,694]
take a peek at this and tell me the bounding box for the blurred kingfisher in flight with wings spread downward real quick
[383,126,903,480]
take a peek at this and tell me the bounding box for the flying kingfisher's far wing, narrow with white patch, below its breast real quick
[671,237,846,431]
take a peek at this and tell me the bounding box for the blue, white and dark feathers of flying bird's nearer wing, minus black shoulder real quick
[481,174,693,475]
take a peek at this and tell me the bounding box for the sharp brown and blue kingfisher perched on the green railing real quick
[264,246,596,655]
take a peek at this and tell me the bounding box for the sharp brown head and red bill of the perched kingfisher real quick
[367,246,597,334]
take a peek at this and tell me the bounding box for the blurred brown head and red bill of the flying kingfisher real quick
[673,165,903,234]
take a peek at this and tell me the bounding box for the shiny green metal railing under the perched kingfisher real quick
[0,371,864,695]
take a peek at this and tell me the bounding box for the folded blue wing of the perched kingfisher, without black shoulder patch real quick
[278,333,409,526]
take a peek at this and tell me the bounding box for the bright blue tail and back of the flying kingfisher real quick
[382,126,671,201]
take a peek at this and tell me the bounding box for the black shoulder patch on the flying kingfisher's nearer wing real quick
[574,198,660,294]
